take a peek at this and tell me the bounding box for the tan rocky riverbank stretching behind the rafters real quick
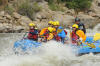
[0,0,100,33]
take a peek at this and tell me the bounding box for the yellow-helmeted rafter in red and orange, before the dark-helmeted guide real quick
[70,24,86,45]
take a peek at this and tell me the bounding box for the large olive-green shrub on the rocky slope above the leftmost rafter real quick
[18,0,41,20]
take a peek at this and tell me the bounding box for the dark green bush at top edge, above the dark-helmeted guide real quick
[66,0,91,10]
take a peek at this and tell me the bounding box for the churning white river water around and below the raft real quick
[0,33,100,66]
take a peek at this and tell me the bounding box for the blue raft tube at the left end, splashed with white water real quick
[13,39,41,52]
